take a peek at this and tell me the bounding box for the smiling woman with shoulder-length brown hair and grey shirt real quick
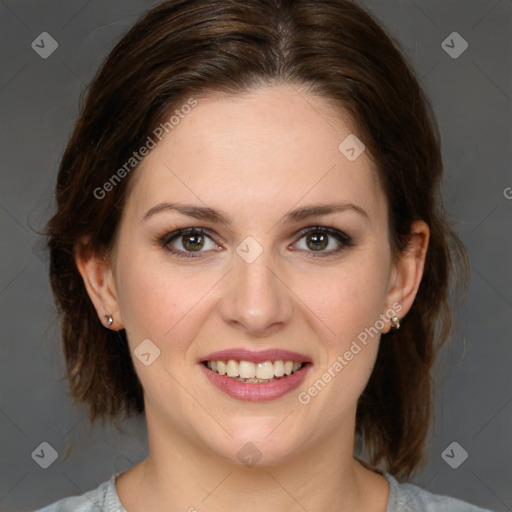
[35,0,492,512]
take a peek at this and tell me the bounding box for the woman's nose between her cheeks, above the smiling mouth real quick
[220,246,293,338]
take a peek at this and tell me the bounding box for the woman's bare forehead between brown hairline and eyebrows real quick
[129,86,385,225]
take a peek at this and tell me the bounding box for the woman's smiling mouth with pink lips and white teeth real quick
[199,350,312,402]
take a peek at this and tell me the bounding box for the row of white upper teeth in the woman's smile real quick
[206,359,302,379]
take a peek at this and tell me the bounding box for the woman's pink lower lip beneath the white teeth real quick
[199,363,311,402]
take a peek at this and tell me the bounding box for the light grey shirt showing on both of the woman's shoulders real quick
[36,472,492,512]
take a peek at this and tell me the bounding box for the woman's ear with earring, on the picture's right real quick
[382,220,430,333]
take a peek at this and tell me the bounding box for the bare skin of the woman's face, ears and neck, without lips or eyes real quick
[76,85,429,512]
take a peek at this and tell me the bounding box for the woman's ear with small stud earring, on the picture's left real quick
[75,243,123,331]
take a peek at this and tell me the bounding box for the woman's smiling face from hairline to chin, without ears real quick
[107,86,408,463]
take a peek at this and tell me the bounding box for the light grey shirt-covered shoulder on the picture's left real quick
[36,475,126,512]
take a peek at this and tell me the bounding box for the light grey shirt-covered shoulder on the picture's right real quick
[384,473,492,512]
